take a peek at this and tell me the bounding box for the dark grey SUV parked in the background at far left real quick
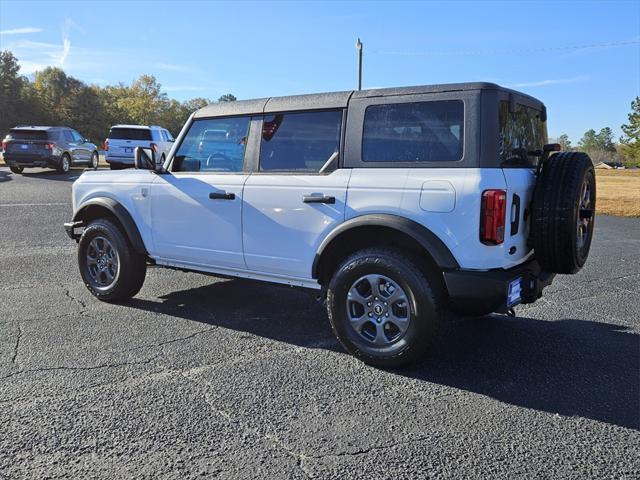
[2,126,98,173]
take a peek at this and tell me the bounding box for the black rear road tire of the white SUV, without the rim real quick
[327,248,445,368]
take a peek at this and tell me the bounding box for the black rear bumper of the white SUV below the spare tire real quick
[444,259,555,315]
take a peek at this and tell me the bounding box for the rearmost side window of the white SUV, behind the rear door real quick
[362,100,464,162]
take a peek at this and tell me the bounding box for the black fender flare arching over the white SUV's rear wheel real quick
[311,213,460,278]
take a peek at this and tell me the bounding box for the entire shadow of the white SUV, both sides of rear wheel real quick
[126,280,640,429]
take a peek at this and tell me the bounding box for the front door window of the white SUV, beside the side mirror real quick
[172,117,251,172]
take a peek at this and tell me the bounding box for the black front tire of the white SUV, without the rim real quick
[78,218,147,302]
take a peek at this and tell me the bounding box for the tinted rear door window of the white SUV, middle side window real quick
[260,111,342,172]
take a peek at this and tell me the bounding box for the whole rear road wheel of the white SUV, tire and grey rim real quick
[327,248,444,368]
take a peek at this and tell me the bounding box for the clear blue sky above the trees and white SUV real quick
[0,0,640,143]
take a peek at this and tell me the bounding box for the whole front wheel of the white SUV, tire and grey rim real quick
[78,219,147,302]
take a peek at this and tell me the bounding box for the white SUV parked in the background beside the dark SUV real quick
[104,125,173,170]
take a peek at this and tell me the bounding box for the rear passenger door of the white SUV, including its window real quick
[242,110,351,279]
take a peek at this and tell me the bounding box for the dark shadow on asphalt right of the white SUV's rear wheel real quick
[398,315,640,429]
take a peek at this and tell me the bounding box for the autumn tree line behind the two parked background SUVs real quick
[0,50,236,145]
